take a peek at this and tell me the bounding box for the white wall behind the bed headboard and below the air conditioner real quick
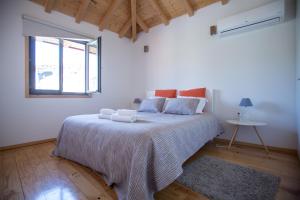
[135,0,297,149]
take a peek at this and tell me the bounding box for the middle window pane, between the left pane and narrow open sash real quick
[63,40,85,93]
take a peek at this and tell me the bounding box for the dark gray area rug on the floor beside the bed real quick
[177,156,280,200]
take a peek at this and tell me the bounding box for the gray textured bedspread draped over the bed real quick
[54,113,221,200]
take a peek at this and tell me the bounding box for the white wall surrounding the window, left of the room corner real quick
[0,0,134,146]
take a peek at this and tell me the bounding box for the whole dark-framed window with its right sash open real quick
[29,37,101,95]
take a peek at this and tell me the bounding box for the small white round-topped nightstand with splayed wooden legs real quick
[226,120,269,153]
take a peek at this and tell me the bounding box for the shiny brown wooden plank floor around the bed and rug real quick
[0,142,300,200]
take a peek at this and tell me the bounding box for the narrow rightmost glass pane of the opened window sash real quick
[89,46,98,92]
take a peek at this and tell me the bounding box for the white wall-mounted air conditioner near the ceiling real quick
[217,0,296,36]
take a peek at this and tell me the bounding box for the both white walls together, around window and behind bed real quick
[0,0,299,148]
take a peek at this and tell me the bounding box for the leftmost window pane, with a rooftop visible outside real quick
[35,37,59,90]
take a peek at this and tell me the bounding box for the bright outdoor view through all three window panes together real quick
[35,37,98,93]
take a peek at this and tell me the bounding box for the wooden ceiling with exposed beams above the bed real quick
[31,0,229,41]
